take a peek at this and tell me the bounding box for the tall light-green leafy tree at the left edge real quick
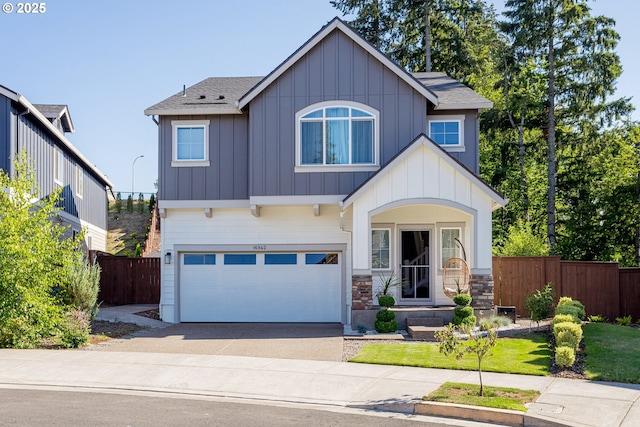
[0,153,86,348]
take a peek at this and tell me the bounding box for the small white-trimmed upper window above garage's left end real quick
[171,120,210,167]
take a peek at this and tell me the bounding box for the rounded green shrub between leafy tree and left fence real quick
[59,260,101,314]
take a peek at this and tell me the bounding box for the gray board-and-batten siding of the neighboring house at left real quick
[0,95,107,230]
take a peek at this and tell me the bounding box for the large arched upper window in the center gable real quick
[296,101,378,172]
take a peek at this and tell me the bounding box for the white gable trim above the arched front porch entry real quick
[342,135,507,210]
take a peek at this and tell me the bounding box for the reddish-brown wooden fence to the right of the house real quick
[493,256,640,320]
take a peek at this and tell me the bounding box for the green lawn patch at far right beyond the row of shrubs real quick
[583,323,640,384]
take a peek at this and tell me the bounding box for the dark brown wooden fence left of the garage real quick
[96,254,160,305]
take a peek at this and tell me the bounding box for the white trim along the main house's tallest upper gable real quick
[238,18,439,109]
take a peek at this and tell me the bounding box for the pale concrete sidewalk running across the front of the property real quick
[0,349,640,427]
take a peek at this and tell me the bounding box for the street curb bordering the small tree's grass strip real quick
[413,402,574,427]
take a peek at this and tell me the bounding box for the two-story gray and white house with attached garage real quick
[145,18,506,325]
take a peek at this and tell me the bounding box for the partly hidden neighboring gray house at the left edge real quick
[0,86,113,251]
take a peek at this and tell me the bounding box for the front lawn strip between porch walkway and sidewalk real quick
[349,334,551,375]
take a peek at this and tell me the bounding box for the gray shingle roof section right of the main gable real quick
[411,72,493,109]
